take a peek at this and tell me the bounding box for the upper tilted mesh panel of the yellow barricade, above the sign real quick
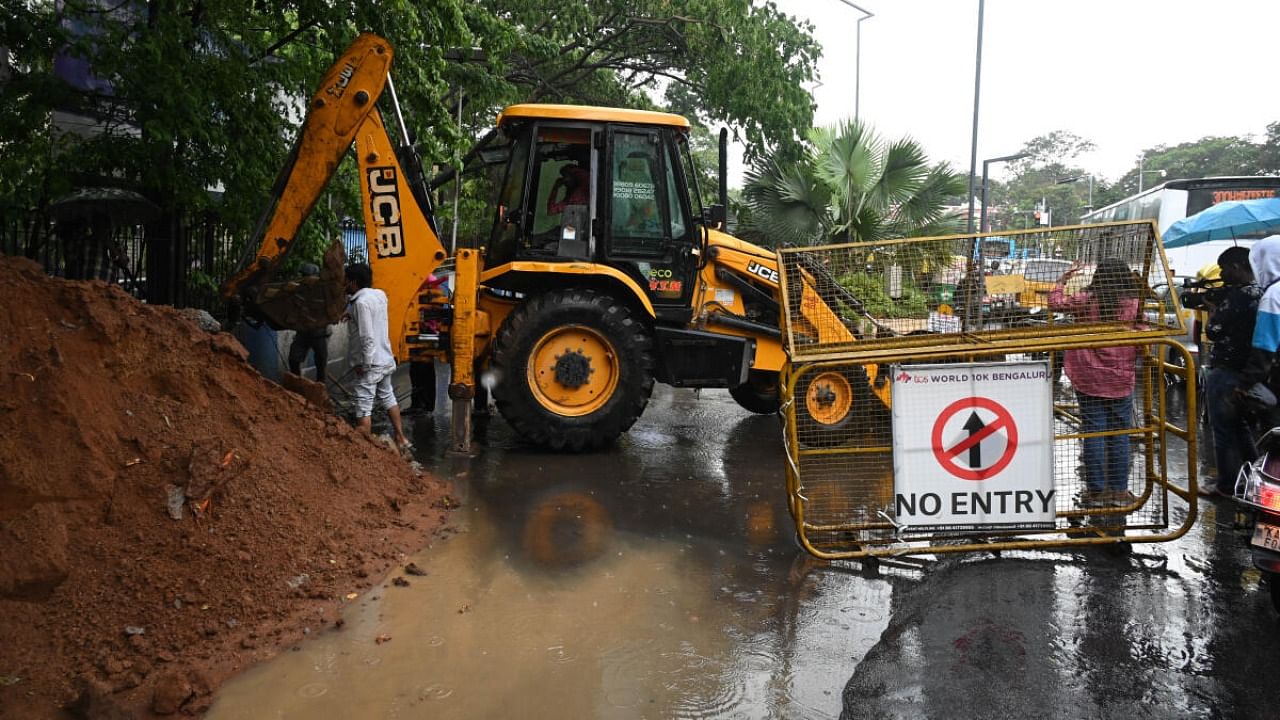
[778,222,1181,360]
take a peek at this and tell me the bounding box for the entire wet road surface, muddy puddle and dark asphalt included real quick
[209,386,1280,720]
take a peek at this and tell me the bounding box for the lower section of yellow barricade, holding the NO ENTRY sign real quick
[783,341,1197,559]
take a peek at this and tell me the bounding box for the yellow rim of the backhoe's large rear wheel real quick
[529,320,620,418]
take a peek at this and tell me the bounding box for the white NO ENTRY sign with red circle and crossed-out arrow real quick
[892,363,1055,529]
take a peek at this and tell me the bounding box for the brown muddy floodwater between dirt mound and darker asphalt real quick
[209,388,892,720]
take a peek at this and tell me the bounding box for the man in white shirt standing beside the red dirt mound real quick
[347,263,410,448]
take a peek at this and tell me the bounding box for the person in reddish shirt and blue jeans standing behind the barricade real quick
[1048,258,1139,507]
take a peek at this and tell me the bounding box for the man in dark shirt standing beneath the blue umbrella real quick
[1201,247,1262,496]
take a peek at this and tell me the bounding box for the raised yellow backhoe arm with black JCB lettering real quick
[221,33,445,360]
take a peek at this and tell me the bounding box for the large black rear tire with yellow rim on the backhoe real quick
[490,288,653,452]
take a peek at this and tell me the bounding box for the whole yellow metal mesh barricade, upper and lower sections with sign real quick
[778,223,1197,559]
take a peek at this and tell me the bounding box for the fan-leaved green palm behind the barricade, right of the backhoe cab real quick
[742,115,965,245]
